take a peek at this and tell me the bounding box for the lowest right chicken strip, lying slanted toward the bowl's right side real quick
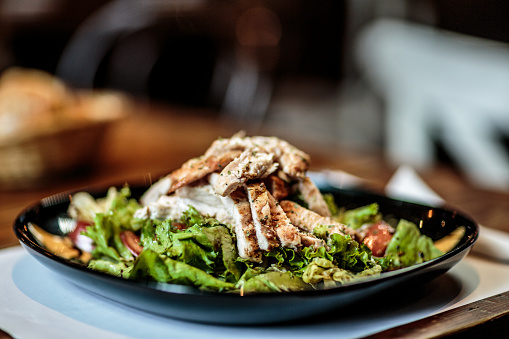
[280,200,358,239]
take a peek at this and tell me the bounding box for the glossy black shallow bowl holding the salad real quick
[13,187,479,324]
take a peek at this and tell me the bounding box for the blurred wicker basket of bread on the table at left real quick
[0,68,128,189]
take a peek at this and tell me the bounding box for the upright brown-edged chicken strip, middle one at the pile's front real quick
[247,181,279,251]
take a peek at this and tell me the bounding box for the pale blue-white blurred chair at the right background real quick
[357,19,509,190]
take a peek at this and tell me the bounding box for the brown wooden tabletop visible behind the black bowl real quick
[0,104,509,338]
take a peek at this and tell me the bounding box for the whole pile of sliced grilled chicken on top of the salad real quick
[137,133,347,262]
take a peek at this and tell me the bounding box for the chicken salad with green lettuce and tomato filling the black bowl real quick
[32,132,444,294]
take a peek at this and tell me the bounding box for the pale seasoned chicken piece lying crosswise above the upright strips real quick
[214,148,278,197]
